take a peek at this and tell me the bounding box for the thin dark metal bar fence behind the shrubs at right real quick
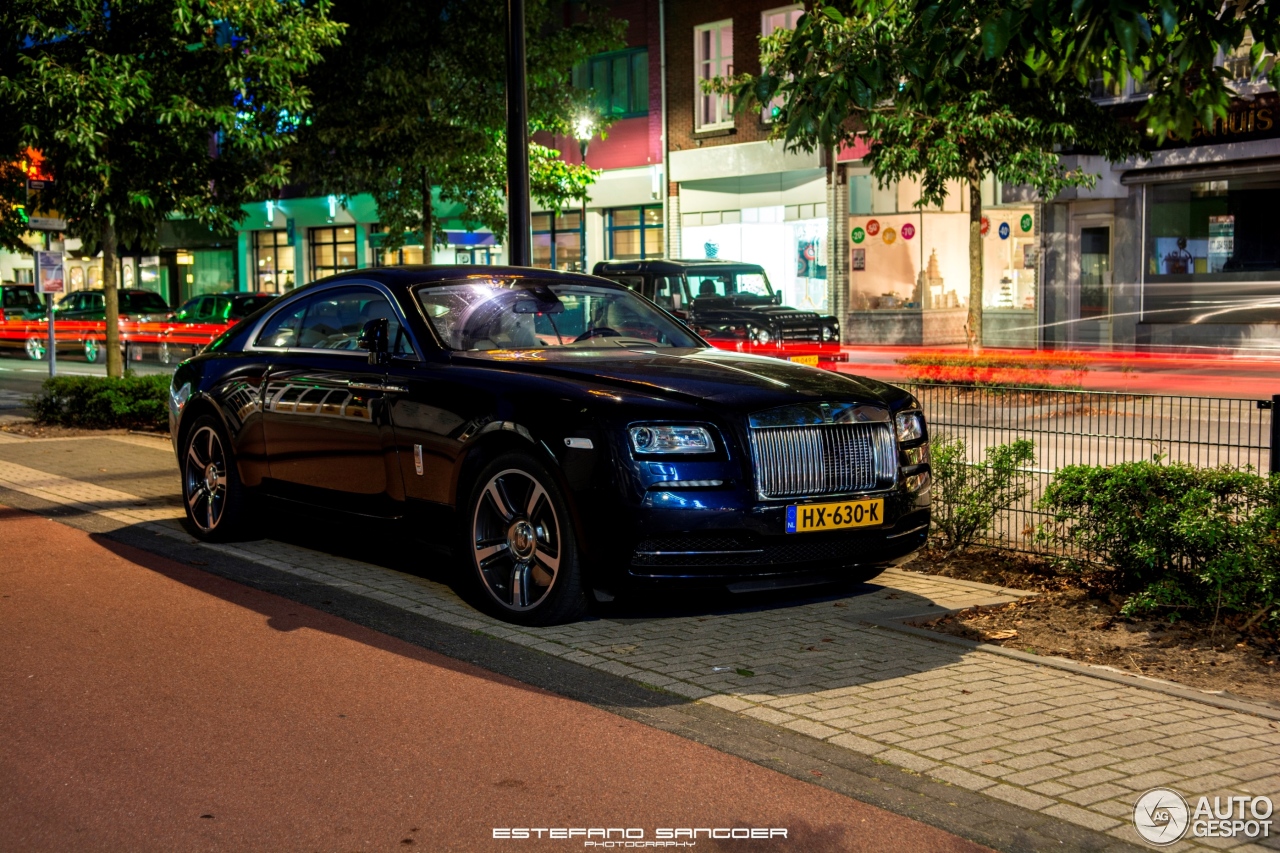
[895,382,1280,553]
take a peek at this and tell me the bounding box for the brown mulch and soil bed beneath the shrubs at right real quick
[910,549,1280,707]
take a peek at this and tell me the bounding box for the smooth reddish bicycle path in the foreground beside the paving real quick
[0,507,986,853]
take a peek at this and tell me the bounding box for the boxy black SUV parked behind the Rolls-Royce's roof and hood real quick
[593,260,840,346]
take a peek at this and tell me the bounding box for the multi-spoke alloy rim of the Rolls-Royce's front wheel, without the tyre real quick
[471,469,562,611]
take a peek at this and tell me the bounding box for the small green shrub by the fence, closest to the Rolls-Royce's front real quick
[929,435,1036,551]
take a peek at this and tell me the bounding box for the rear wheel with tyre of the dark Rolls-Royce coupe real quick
[182,415,248,542]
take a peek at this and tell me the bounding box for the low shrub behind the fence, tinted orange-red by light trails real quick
[897,352,1089,388]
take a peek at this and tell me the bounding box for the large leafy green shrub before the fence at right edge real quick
[1039,461,1280,622]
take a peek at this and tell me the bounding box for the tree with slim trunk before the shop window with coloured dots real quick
[713,0,1139,351]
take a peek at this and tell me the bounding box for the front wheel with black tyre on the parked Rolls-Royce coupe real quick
[462,453,586,625]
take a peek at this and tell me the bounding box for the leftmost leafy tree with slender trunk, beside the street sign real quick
[0,0,340,377]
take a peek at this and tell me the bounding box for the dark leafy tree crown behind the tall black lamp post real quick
[297,0,625,253]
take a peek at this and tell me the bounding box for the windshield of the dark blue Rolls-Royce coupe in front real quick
[417,278,703,351]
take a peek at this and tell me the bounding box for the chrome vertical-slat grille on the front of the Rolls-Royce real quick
[751,423,895,498]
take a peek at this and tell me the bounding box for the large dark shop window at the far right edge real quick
[1143,174,1280,323]
